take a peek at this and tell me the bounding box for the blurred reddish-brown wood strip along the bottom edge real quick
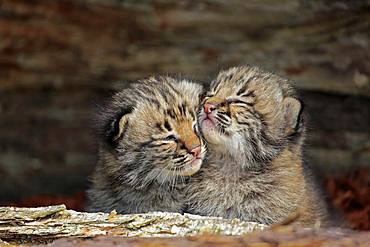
[39,231,370,247]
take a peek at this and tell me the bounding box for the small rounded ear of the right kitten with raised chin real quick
[283,97,303,136]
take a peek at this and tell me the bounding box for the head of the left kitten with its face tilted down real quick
[102,77,205,186]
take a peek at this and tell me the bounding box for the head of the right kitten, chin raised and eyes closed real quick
[199,67,303,165]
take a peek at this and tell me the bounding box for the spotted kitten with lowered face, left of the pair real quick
[88,77,205,213]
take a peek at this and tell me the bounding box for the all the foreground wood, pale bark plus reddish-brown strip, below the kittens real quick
[0,205,370,246]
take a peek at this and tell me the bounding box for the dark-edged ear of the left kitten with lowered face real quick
[105,107,133,146]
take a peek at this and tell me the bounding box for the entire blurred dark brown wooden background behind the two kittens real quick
[0,0,370,229]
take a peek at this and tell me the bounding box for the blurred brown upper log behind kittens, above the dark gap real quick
[0,0,370,96]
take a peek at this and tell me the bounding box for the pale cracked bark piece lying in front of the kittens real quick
[0,205,266,244]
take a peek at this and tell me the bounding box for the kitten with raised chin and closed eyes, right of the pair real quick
[187,67,326,225]
